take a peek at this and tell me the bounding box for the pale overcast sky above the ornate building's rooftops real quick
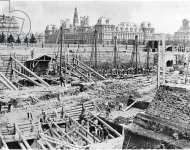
[0,0,190,33]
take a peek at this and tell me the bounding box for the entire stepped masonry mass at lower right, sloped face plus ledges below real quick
[124,85,190,148]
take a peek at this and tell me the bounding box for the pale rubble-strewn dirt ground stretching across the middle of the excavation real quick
[0,77,155,126]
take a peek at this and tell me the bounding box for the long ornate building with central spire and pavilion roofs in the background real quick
[45,8,154,45]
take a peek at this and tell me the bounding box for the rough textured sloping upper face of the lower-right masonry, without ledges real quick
[147,86,190,128]
